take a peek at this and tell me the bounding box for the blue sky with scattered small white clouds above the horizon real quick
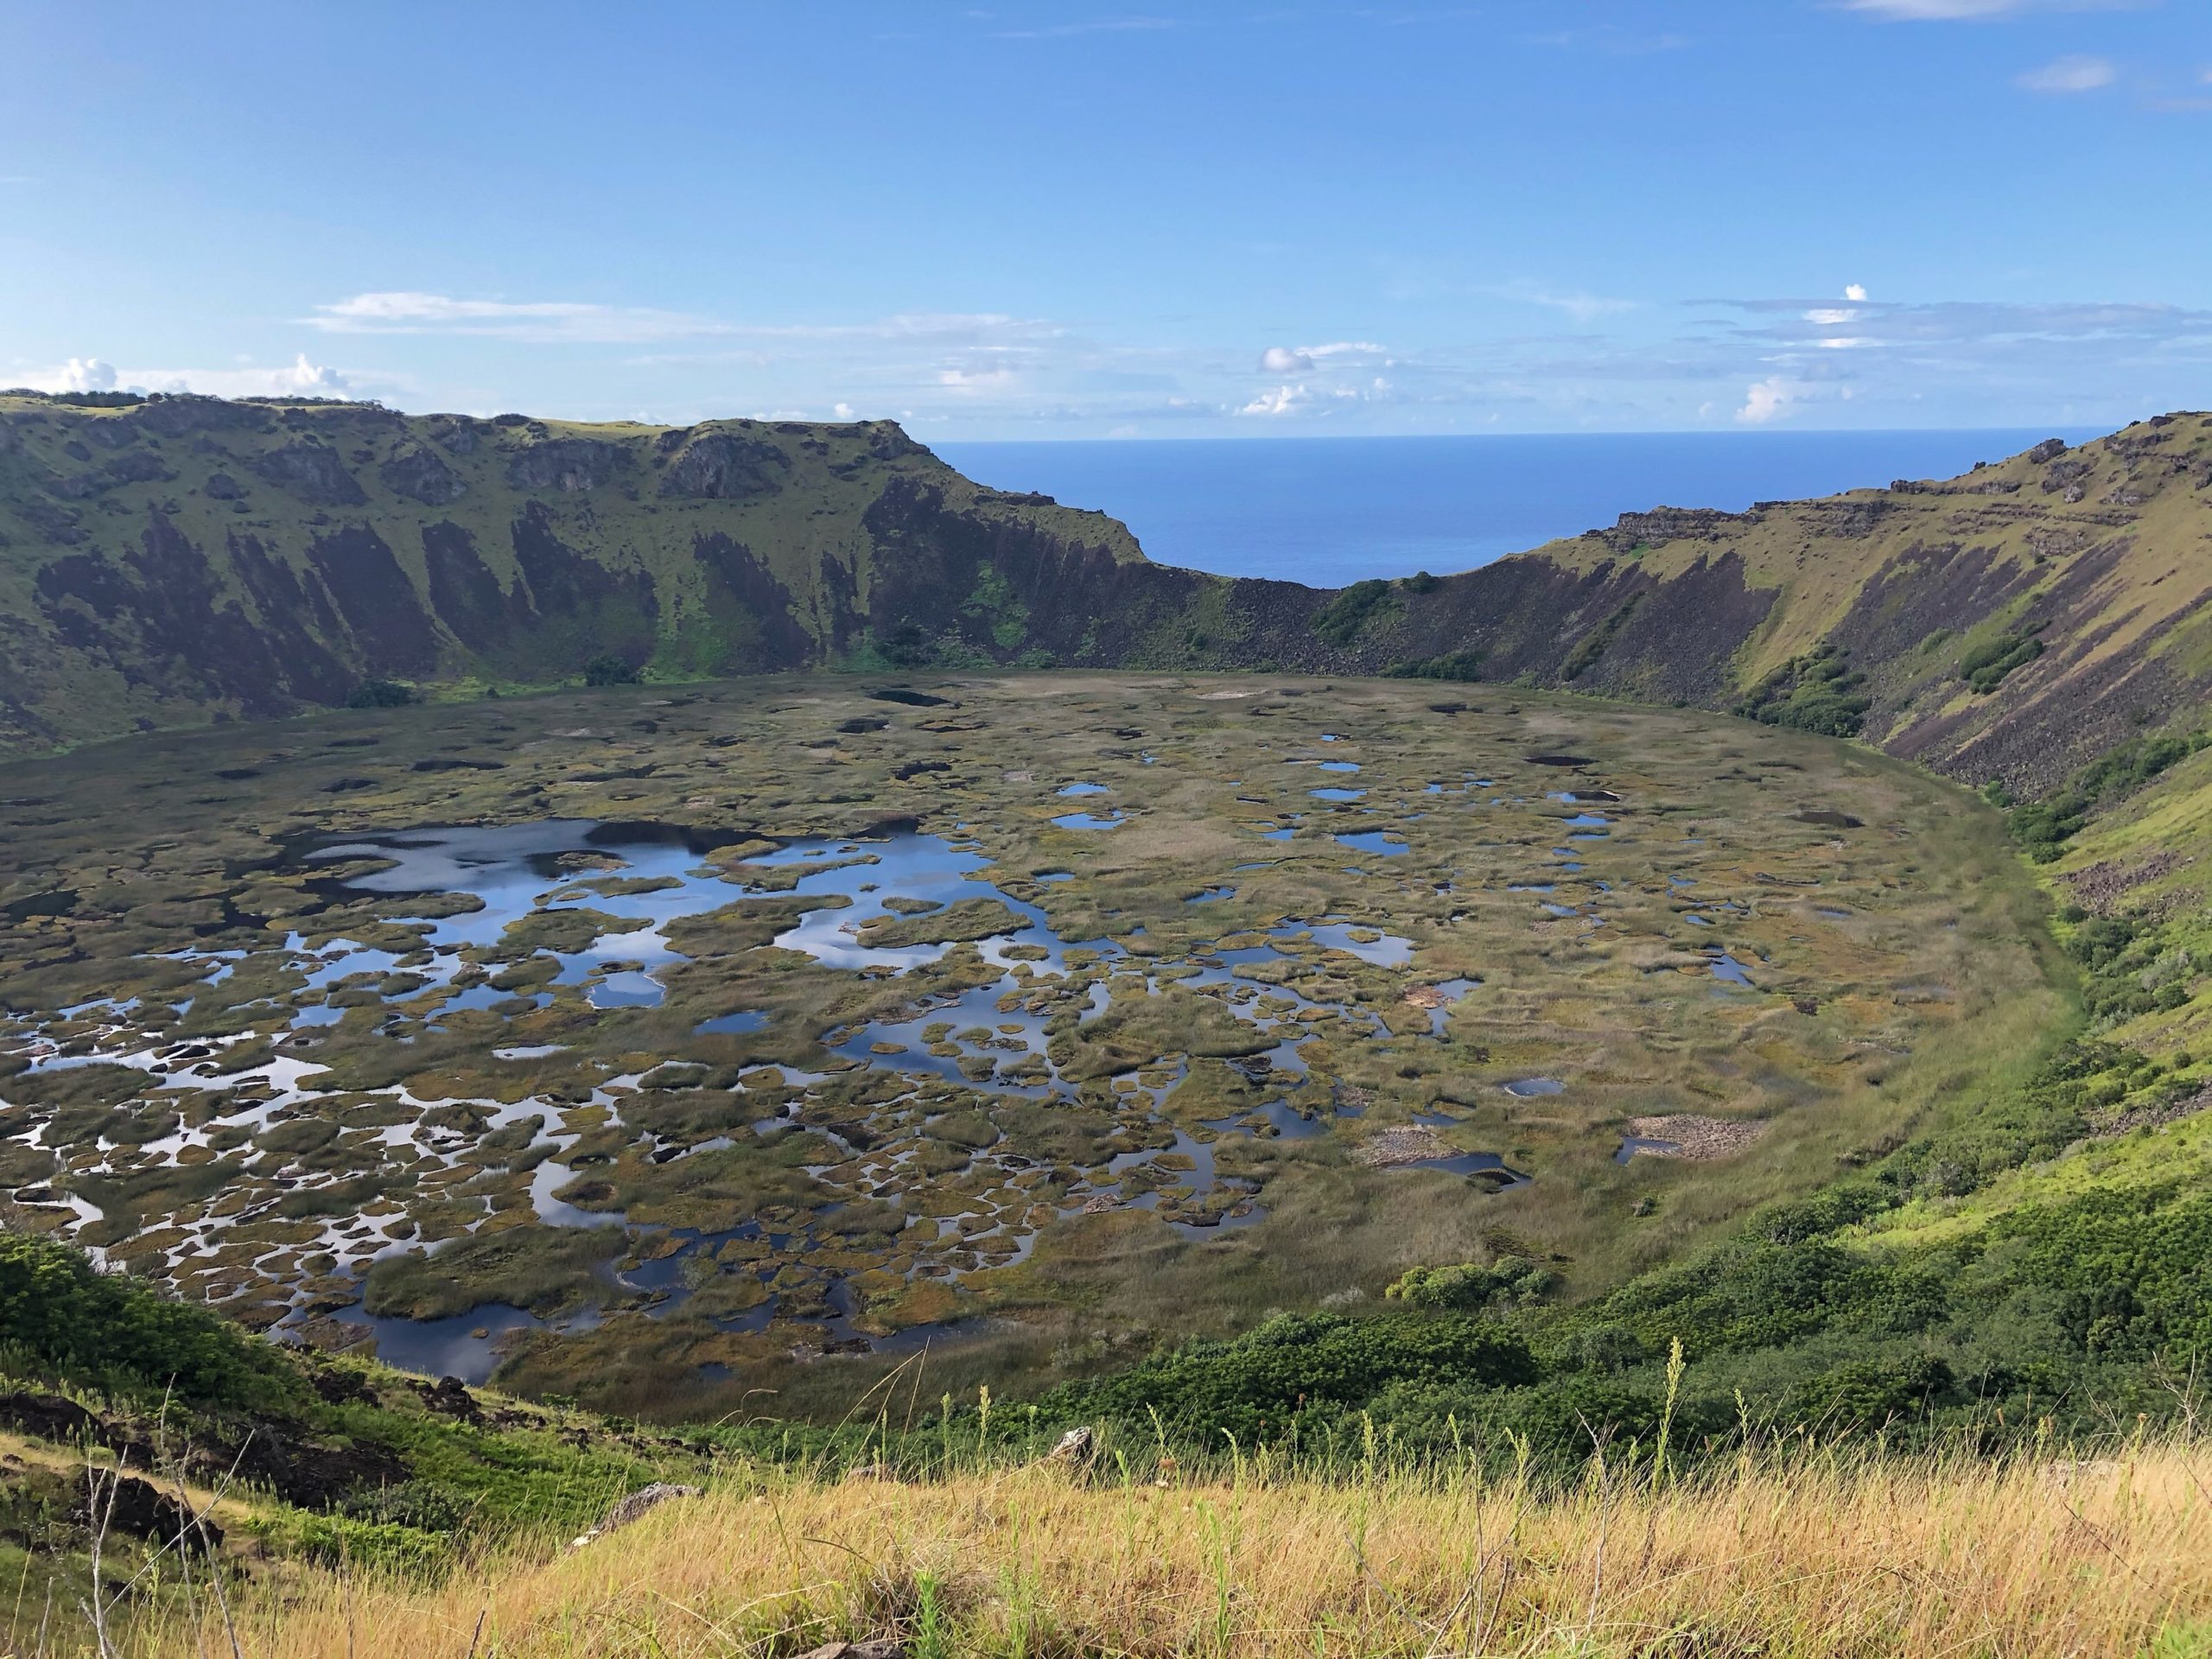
[0,0,2212,440]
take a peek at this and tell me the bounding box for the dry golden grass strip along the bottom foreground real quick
[124,1445,2212,1659]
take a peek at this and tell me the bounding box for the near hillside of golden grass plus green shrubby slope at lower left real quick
[0,1239,2212,1659]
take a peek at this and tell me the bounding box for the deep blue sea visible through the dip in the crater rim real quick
[936,427,2094,586]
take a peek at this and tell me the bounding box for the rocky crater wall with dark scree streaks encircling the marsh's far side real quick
[0,394,2212,790]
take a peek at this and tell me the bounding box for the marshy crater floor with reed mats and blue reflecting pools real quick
[0,675,2053,1415]
